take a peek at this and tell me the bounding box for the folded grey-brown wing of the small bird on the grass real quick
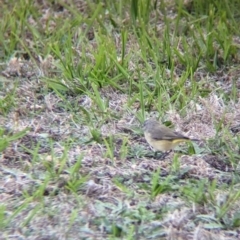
[151,126,189,140]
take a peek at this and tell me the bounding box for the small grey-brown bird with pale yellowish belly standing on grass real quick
[143,119,198,158]
